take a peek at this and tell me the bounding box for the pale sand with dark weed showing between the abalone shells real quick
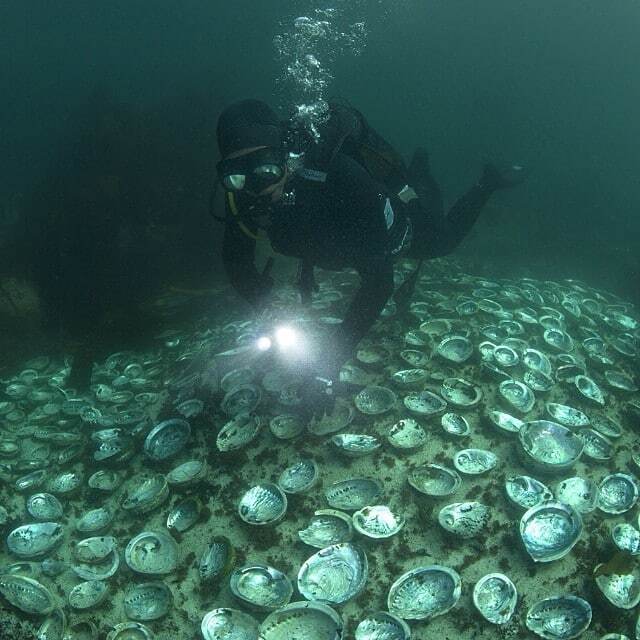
[0,262,639,640]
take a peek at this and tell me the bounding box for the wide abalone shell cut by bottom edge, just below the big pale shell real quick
[258,602,343,640]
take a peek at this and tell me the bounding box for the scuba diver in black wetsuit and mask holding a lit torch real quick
[217,100,524,416]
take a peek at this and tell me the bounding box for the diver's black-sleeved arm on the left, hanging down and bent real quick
[222,220,273,310]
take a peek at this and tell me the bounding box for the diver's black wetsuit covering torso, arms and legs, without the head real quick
[223,148,494,376]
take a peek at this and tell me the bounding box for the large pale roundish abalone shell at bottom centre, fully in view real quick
[298,542,368,604]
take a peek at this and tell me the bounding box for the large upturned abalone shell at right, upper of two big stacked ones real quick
[518,420,584,473]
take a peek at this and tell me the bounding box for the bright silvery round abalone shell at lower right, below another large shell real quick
[520,502,582,562]
